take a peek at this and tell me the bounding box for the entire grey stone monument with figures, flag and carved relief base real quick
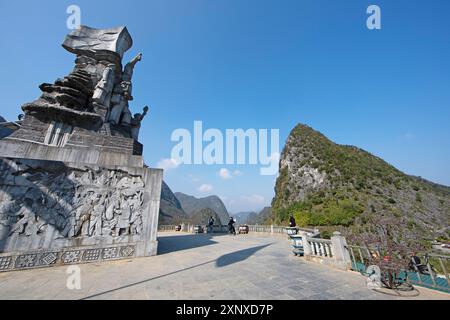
[0,26,162,272]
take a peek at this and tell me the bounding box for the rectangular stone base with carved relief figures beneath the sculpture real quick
[0,158,162,272]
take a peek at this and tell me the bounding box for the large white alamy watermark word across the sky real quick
[171,121,280,176]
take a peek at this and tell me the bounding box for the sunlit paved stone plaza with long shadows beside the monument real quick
[0,233,450,300]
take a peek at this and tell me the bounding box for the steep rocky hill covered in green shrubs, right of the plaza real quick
[272,125,450,239]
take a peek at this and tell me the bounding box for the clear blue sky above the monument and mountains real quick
[0,0,450,212]
